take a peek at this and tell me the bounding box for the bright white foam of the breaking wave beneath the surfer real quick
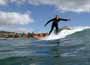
[44,26,90,40]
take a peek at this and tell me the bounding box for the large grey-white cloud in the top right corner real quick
[56,0,90,12]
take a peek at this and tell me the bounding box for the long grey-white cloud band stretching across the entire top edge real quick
[0,0,90,12]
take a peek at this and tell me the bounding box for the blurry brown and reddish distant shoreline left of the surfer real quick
[0,31,48,40]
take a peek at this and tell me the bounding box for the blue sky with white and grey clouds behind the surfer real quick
[0,0,90,32]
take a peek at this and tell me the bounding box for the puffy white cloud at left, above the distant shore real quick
[0,11,33,25]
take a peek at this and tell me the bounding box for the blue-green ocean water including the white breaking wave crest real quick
[0,28,90,65]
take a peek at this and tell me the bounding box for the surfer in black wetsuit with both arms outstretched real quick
[44,15,70,35]
